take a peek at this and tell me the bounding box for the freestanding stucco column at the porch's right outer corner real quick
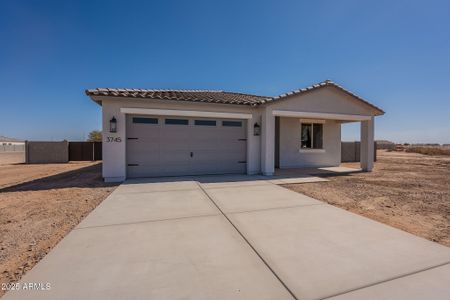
[360,117,375,172]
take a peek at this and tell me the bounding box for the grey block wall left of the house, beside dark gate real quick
[25,141,69,164]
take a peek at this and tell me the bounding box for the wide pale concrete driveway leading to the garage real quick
[4,176,450,300]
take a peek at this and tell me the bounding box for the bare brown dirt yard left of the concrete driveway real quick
[0,163,117,296]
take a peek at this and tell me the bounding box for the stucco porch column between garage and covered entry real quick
[261,107,275,176]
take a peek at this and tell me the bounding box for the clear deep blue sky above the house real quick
[0,0,450,143]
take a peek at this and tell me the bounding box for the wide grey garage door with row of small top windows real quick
[127,115,247,178]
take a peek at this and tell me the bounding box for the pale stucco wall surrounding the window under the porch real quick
[280,117,341,168]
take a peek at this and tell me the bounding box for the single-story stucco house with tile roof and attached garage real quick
[86,80,384,181]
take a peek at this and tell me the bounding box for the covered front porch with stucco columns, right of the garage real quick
[261,109,375,175]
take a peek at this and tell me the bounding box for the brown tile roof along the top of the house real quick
[85,80,384,114]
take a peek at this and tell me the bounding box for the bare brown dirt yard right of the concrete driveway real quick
[285,151,450,247]
